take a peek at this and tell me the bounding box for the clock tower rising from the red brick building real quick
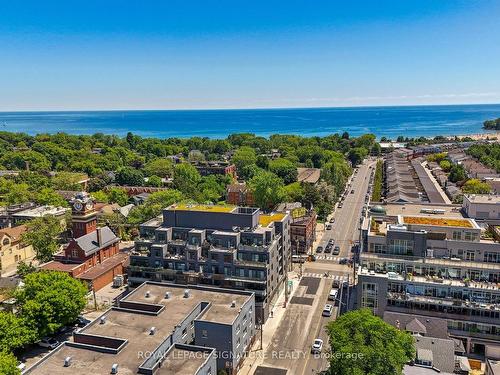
[70,191,97,238]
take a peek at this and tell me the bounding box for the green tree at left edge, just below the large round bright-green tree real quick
[0,311,36,352]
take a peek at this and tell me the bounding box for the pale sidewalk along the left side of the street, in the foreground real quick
[238,271,300,375]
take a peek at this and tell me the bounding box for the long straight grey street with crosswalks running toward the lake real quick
[250,161,375,374]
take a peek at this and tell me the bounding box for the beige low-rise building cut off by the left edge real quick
[0,225,35,272]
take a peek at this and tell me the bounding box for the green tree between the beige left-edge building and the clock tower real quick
[21,215,62,263]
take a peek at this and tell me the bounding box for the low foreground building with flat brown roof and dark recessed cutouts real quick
[24,282,255,375]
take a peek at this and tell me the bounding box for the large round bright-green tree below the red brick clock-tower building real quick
[16,271,88,338]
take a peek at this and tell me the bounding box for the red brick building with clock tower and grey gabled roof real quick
[41,193,128,291]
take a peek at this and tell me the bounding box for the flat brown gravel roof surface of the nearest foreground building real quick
[27,283,251,375]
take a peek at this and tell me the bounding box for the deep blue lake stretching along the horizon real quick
[0,104,500,138]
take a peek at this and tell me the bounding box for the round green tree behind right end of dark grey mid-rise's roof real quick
[249,171,285,210]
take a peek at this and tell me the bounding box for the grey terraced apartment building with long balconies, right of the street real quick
[358,204,500,354]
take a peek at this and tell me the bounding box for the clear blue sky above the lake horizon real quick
[0,0,500,111]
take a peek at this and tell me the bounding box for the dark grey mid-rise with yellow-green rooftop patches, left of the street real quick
[129,204,291,322]
